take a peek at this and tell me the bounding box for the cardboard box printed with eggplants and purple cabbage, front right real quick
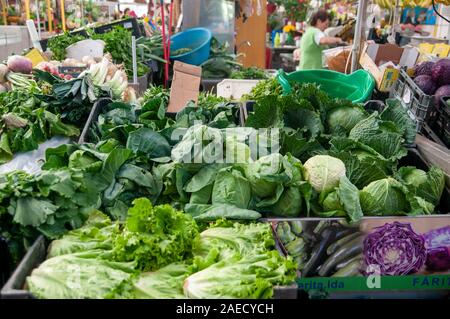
[271,215,450,293]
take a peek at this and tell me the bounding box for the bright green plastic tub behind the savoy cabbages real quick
[276,70,375,103]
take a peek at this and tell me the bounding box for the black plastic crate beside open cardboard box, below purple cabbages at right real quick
[390,69,434,132]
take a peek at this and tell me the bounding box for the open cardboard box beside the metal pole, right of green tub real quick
[359,43,419,92]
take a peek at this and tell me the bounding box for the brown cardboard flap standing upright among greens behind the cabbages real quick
[167,61,202,113]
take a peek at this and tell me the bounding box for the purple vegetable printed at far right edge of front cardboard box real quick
[423,226,450,271]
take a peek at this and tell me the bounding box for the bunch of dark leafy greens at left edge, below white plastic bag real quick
[0,170,100,238]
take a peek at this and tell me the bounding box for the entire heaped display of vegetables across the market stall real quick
[0,12,450,298]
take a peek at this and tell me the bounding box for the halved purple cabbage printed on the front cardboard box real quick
[363,222,427,276]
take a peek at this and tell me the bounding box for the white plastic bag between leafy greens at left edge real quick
[0,136,71,174]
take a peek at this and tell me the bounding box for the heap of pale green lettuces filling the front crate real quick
[27,212,295,298]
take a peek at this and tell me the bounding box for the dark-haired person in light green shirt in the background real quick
[300,10,342,70]
